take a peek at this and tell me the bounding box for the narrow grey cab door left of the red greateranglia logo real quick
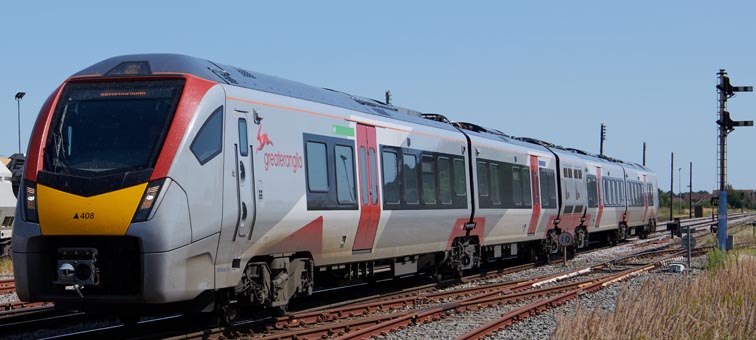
[232,110,255,241]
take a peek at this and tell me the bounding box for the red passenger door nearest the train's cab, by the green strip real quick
[352,124,381,251]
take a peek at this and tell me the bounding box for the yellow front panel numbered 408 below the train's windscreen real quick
[37,183,147,235]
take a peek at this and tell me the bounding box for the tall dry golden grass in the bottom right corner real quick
[552,251,756,340]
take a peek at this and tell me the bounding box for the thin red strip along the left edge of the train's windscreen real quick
[24,83,65,182]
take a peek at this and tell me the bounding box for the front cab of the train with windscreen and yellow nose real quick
[13,71,230,313]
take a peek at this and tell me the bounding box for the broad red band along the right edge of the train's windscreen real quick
[150,75,217,181]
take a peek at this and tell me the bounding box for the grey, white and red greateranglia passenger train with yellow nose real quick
[12,54,659,322]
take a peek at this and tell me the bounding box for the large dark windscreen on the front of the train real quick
[44,80,184,177]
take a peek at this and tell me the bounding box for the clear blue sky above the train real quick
[0,0,756,191]
